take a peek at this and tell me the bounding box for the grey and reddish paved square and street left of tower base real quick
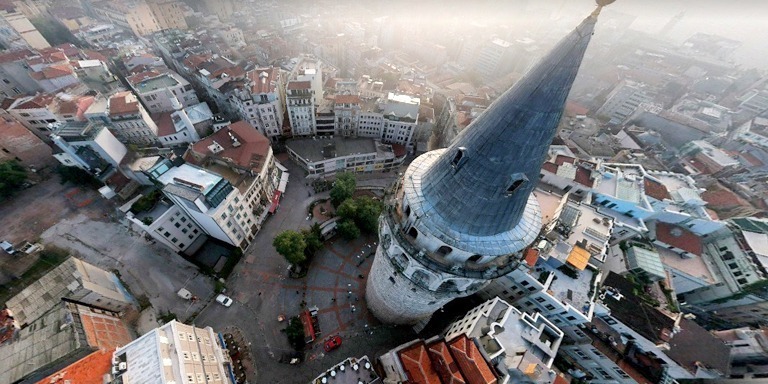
[195,157,413,383]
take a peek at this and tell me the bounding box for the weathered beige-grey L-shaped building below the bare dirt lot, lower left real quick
[6,257,134,328]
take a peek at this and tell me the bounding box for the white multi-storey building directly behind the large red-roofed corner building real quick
[229,67,288,141]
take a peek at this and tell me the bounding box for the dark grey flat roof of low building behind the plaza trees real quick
[286,137,383,163]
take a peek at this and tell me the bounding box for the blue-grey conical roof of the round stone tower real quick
[421,7,600,236]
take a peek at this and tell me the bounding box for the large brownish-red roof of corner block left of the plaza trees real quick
[190,121,270,169]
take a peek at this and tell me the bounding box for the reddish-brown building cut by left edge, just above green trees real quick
[0,119,55,170]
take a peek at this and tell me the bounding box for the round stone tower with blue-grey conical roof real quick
[366,6,602,324]
